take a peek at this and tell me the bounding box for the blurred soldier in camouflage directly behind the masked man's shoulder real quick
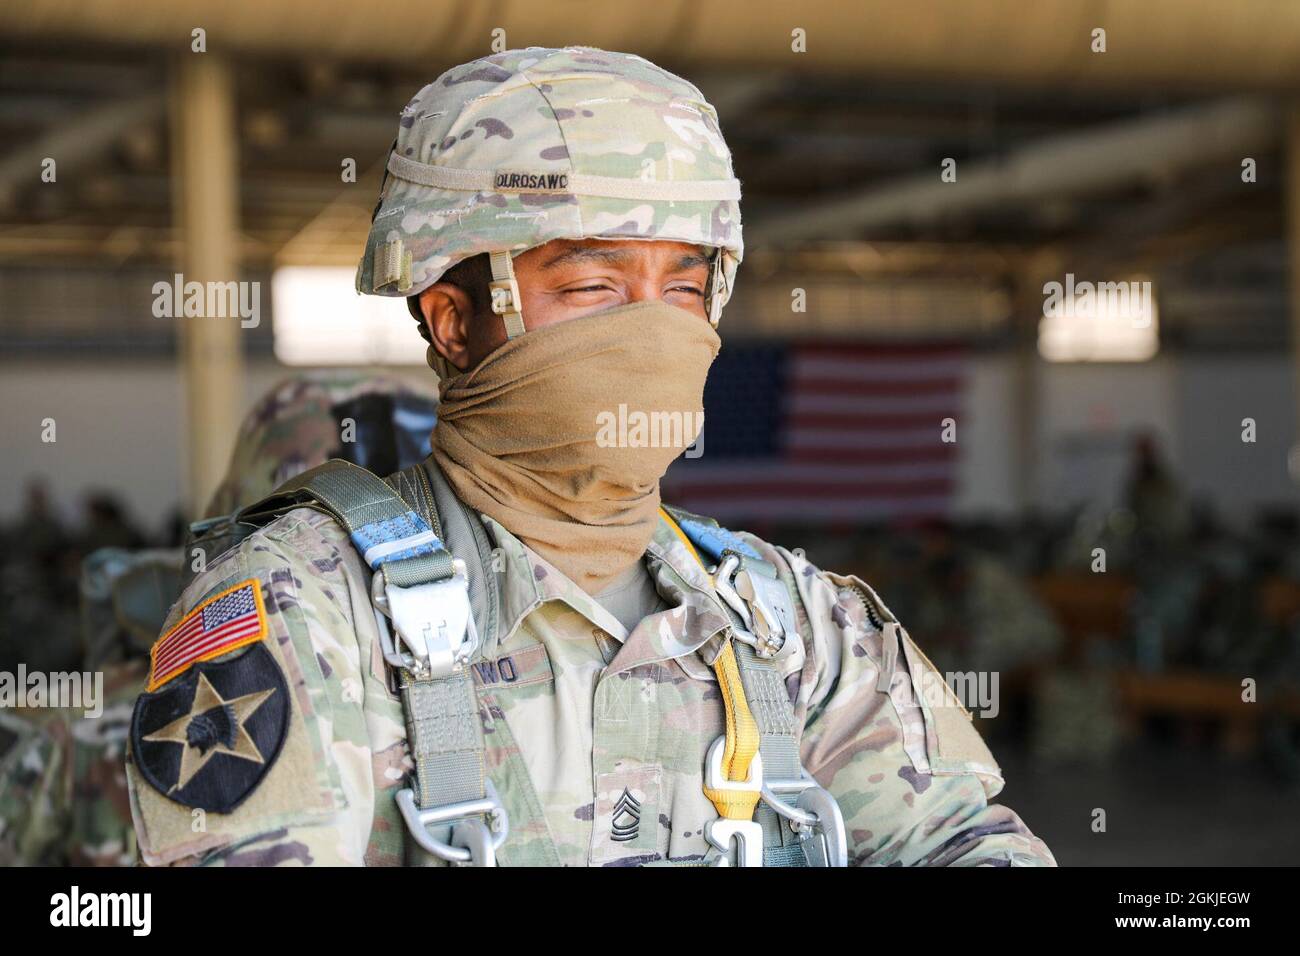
[0,372,437,866]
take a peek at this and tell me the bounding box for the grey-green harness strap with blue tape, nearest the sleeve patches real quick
[245,459,508,865]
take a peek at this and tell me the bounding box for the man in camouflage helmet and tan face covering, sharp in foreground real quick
[129,48,1054,865]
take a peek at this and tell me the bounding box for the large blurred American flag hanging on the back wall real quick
[663,343,966,523]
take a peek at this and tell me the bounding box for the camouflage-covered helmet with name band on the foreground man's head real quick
[356,47,742,324]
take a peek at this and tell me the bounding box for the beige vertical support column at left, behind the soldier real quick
[172,52,243,516]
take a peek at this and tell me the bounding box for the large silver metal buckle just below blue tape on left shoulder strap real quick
[371,558,478,680]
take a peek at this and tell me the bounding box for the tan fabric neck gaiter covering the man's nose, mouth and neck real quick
[433,300,722,594]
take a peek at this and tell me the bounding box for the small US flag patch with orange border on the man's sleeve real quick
[146,578,267,692]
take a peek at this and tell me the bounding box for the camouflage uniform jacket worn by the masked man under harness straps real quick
[129,509,1054,866]
